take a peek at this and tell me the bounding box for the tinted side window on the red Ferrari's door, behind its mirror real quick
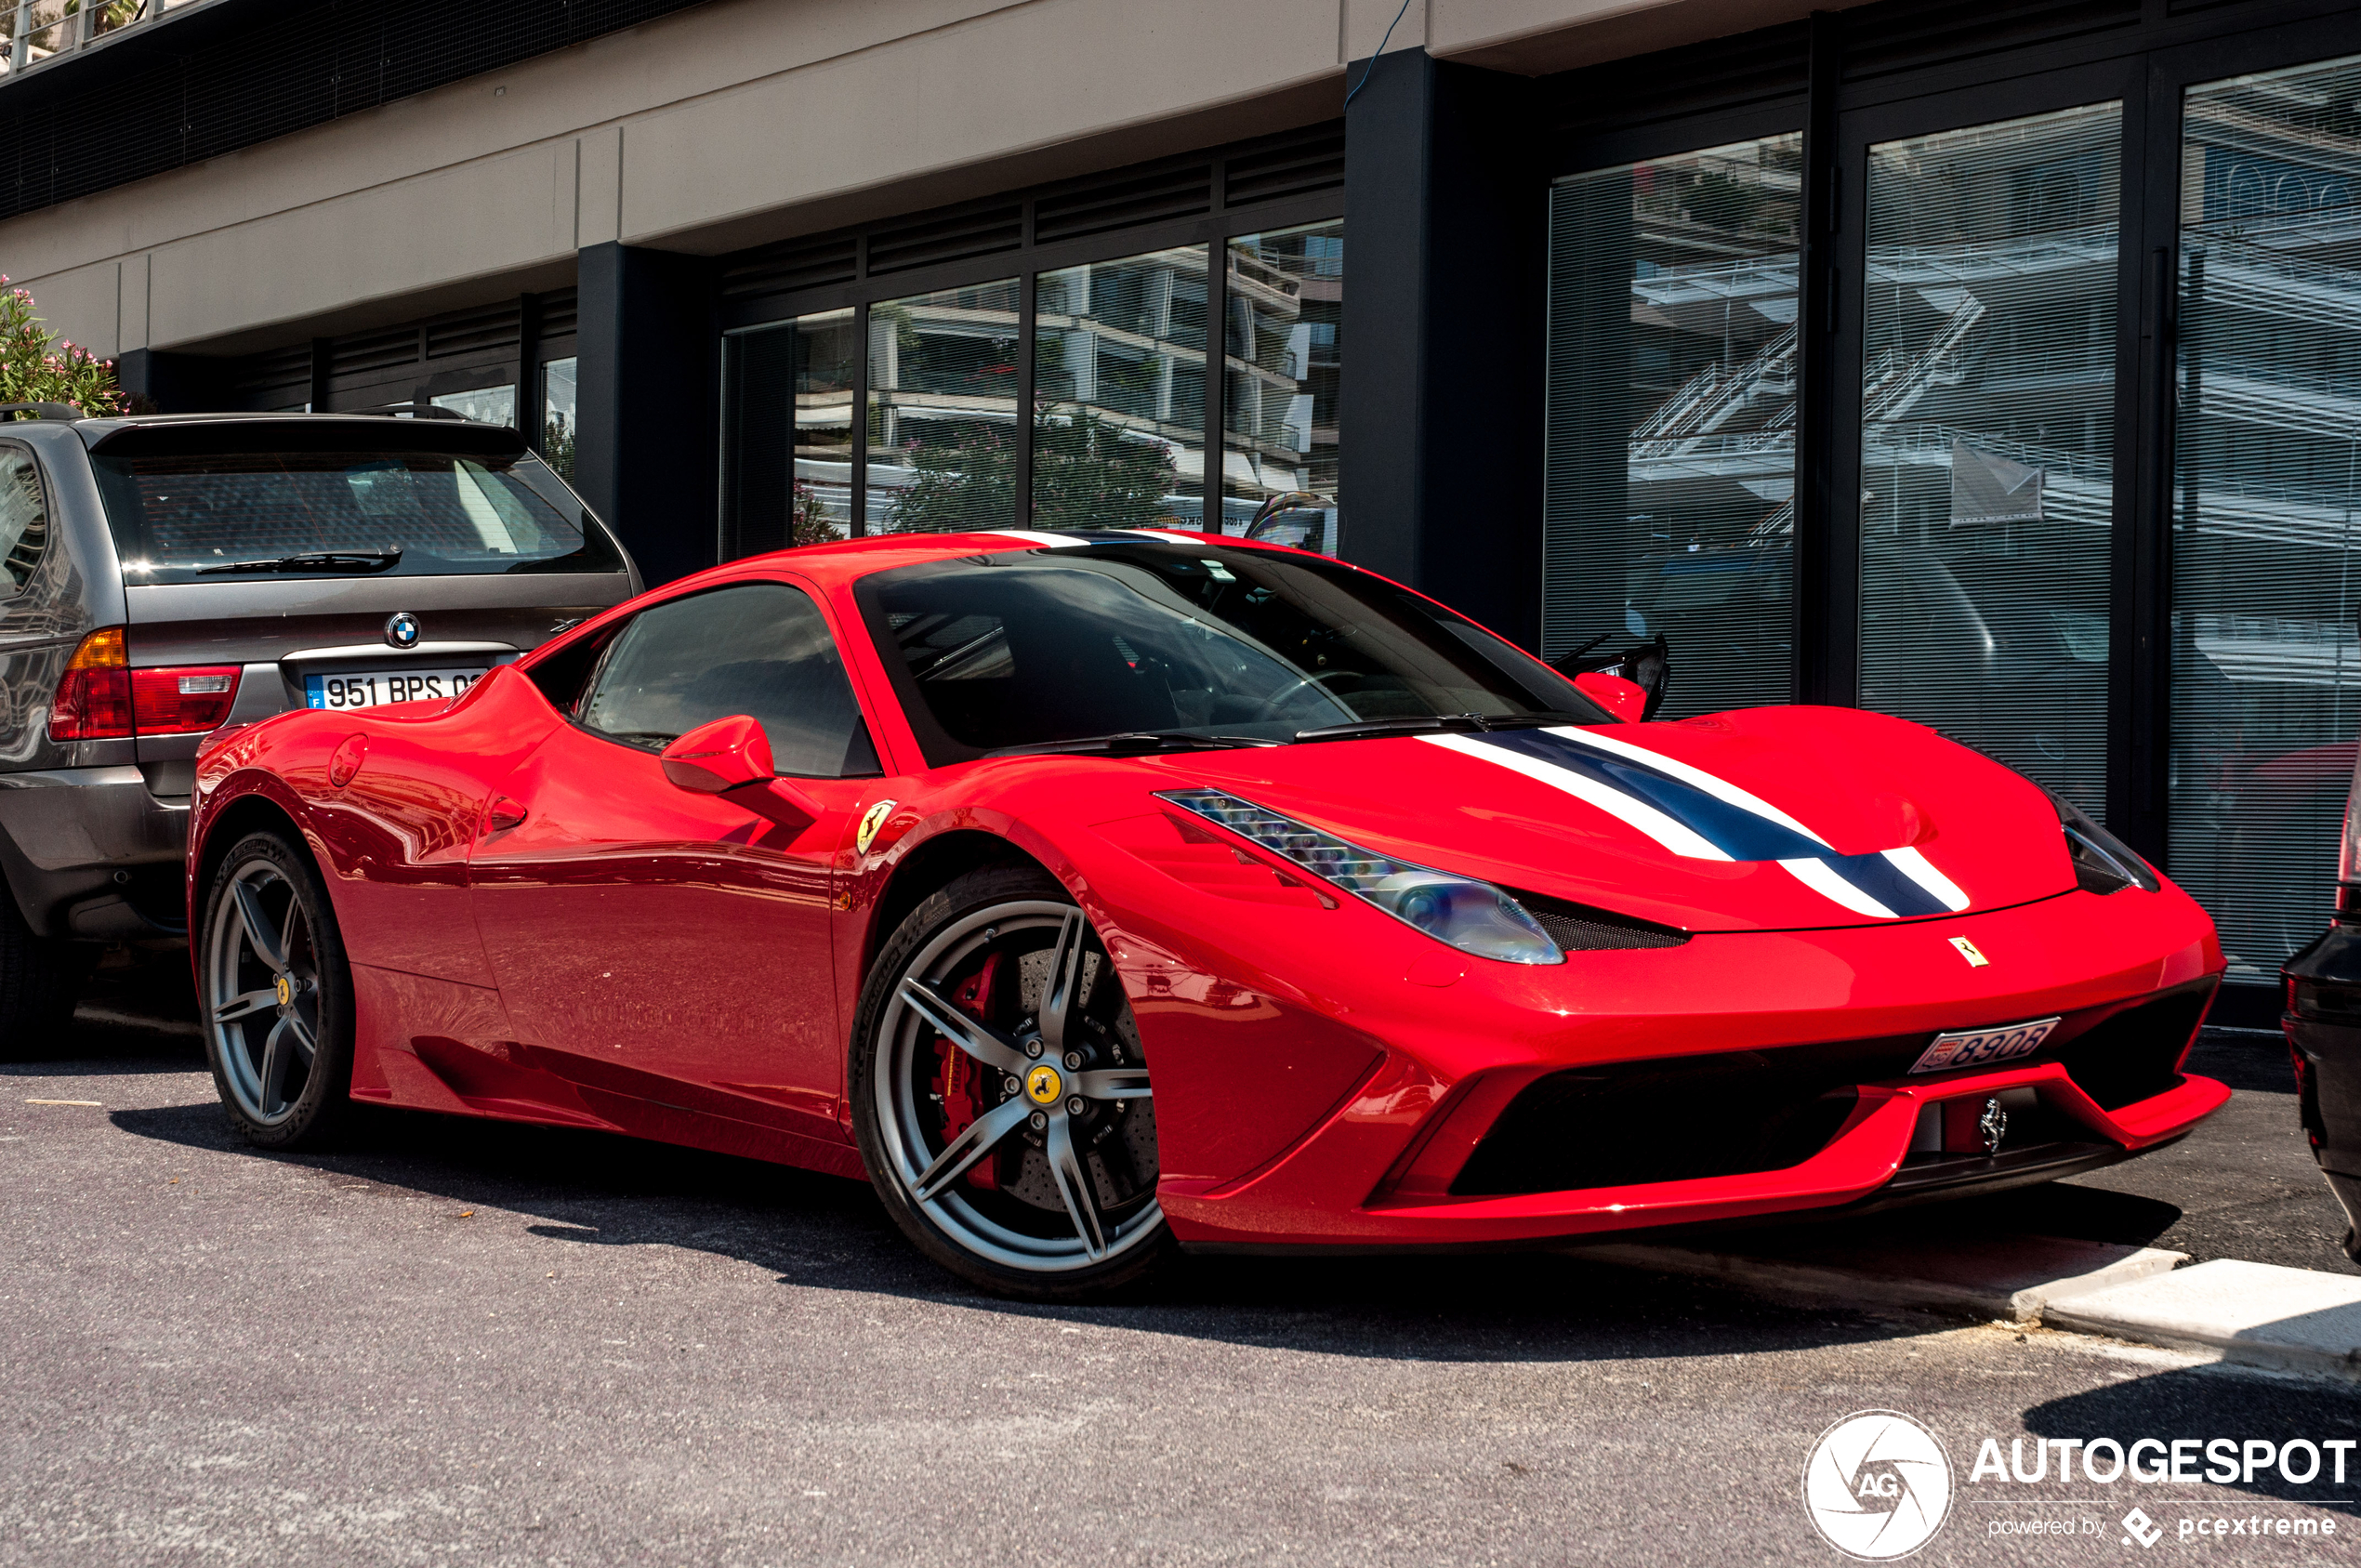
[574,584,878,779]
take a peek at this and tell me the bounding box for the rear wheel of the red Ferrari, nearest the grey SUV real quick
[196,834,351,1148]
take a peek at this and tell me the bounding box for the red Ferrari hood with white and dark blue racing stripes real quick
[1153,706,2076,930]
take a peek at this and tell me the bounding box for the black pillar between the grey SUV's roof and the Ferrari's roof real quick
[574,244,720,588]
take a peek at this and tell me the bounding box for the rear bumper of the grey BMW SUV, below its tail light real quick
[0,763,189,942]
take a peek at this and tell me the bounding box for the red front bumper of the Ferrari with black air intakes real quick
[1142,892,2229,1249]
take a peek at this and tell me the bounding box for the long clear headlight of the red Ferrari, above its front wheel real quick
[1157,789,1565,964]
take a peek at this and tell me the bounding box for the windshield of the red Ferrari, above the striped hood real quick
[854,541,1605,765]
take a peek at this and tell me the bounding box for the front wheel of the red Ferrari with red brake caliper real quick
[845,866,1173,1301]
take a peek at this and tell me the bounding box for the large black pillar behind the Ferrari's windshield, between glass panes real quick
[1339,49,1547,650]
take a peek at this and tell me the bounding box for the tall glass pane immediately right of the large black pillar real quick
[1542,135,1804,718]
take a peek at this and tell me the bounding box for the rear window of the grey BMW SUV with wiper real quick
[90,420,624,584]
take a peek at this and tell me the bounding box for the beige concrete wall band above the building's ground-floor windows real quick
[0,0,1778,354]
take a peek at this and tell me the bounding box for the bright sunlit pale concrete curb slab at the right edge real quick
[2042,1258,2361,1379]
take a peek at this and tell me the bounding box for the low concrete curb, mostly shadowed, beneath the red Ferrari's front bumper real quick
[1575,1235,2189,1323]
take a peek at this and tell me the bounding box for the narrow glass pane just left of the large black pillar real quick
[1220,222,1343,538]
